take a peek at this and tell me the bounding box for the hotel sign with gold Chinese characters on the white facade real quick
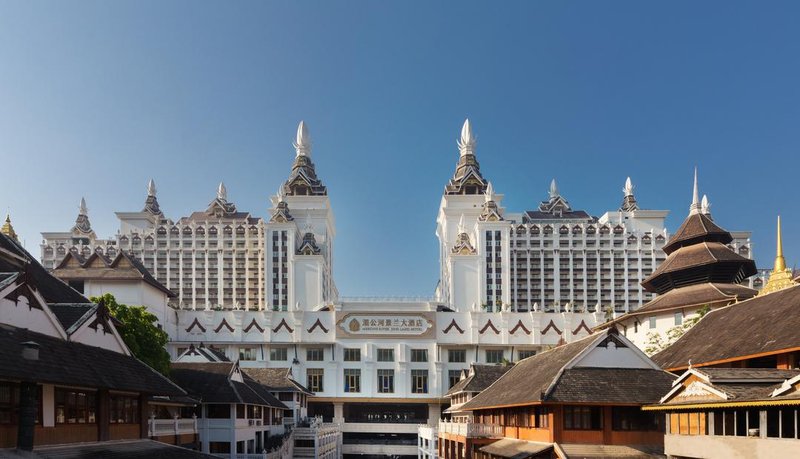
[336,313,434,338]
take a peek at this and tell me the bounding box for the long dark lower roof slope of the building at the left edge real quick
[0,324,186,395]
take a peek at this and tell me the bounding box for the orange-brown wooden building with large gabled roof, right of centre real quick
[439,329,674,459]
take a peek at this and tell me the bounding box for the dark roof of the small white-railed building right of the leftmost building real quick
[170,362,286,409]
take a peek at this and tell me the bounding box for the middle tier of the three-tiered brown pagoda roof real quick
[642,242,757,293]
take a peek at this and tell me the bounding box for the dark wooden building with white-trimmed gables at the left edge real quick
[0,234,186,450]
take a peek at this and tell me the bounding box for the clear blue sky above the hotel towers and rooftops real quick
[0,1,800,295]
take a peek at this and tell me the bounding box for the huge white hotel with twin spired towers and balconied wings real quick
[42,121,750,457]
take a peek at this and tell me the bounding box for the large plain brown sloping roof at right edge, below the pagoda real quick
[652,285,800,370]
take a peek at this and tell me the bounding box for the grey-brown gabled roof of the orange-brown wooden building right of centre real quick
[460,329,673,411]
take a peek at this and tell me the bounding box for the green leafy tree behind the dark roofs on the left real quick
[91,293,169,375]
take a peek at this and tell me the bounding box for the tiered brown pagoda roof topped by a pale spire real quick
[640,174,756,311]
